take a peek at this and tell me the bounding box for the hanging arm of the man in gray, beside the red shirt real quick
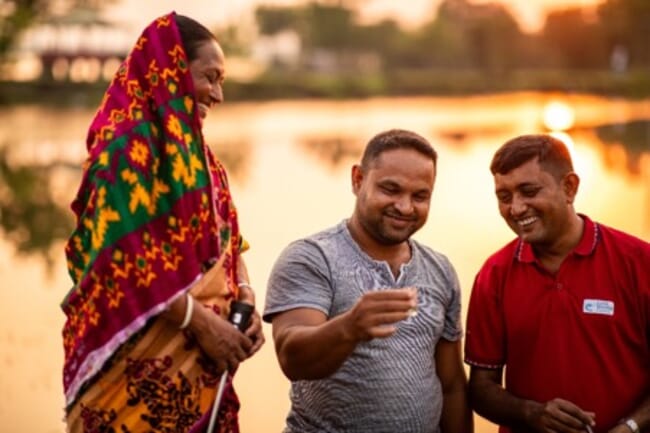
[435,338,474,433]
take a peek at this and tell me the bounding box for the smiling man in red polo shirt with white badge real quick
[465,135,650,433]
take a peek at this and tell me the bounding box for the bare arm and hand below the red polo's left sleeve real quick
[469,366,595,433]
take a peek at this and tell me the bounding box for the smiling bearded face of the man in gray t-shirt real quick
[352,149,435,245]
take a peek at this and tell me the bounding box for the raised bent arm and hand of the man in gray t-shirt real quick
[272,289,416,380]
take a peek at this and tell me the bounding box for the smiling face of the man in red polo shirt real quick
[494,158,577,247]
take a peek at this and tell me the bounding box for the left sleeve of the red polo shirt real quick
[465,263,506,368]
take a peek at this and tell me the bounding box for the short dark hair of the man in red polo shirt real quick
[490,134,573,180]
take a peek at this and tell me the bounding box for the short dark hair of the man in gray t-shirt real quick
[361,129,438,169]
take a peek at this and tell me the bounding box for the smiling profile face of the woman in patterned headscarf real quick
[190,39,226,121]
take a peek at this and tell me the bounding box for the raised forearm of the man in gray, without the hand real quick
[275,310,358,380]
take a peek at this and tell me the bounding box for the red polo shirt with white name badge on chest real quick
[465,215,650,433]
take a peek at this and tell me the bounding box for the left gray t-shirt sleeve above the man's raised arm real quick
[262,240,332,322]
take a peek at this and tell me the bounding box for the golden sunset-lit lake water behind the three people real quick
[0,93,650,433]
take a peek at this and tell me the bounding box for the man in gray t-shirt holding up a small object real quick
[264,130,473,433]
